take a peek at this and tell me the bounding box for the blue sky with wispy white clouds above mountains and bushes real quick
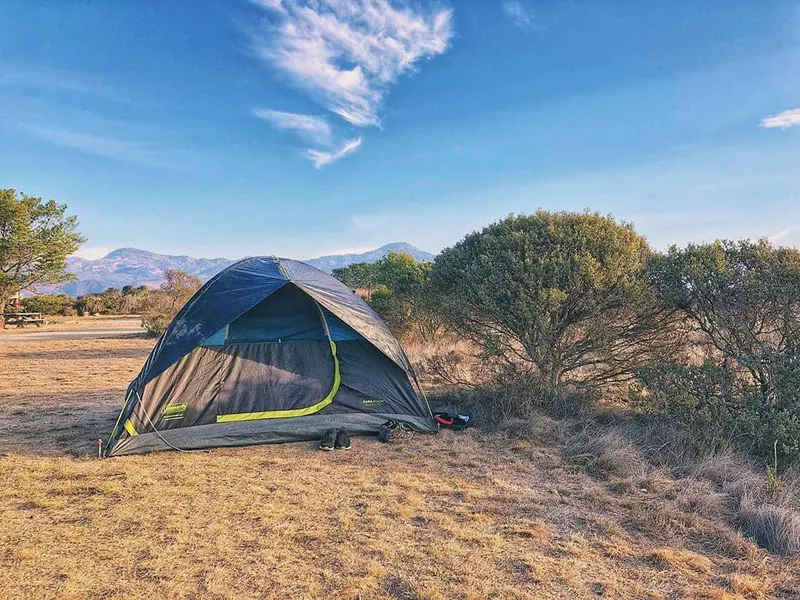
[0,0,800,258]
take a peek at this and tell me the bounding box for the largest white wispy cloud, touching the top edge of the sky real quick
[253,0,453,127]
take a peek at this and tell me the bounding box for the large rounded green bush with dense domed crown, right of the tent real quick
[431,211,672,389]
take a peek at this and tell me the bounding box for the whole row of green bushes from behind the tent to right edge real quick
[334,211,800,466]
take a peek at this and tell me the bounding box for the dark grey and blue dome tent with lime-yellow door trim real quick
[105,257,435,456]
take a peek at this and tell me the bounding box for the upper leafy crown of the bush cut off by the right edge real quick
[652,240,800,394]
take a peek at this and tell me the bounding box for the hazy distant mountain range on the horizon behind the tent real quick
[54,242,434,296]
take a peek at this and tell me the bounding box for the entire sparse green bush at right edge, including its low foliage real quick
[640,240,800,465]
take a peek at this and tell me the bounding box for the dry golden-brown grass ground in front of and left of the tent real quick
[0,330,800,599]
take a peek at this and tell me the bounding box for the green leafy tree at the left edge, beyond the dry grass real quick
[0,189,85,322]
